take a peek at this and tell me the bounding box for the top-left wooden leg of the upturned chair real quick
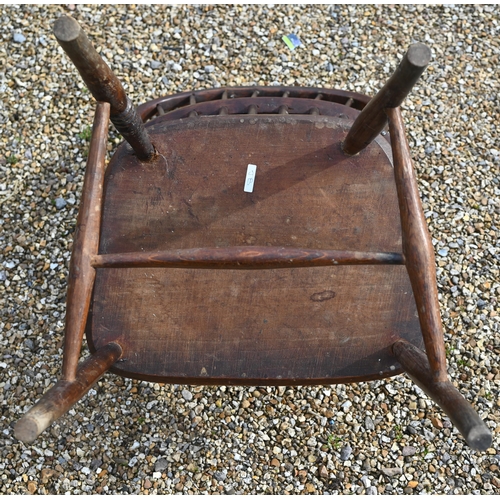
[54,16,156,161]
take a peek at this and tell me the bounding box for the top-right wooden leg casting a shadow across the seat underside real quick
[342,43,431,155]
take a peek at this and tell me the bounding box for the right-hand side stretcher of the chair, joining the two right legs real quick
[387,108,448,382]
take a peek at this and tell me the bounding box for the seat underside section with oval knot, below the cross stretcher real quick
[91,266,422,385]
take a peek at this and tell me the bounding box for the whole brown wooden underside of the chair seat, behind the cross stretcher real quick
[88,112,422,384]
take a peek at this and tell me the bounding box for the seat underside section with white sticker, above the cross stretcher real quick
[100,114,401,253]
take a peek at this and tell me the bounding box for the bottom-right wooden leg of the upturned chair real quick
[392,340,492,451]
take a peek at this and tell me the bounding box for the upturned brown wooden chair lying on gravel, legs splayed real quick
[15,16,491,450]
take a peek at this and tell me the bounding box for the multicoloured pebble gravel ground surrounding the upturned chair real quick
[0,5,500,494]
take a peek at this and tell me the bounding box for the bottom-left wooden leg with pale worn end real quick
[14,343,122,443]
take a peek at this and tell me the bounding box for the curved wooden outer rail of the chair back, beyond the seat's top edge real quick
[137,86,370,121]
